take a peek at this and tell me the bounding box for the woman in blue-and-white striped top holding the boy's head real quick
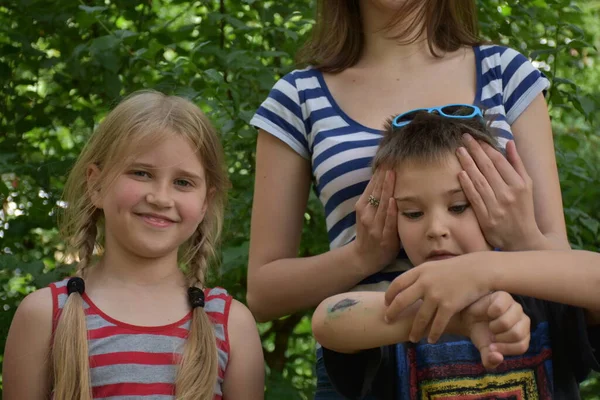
[248,0,569,398]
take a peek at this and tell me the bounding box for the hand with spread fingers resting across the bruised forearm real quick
[385,253,493,343]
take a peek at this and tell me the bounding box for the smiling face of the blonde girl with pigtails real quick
[95,135,208,258]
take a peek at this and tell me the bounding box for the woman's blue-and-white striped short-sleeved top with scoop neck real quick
[250,45,549,290]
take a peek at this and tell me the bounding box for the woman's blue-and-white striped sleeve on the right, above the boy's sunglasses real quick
[501,48,550,125]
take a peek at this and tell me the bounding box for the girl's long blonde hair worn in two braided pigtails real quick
[52,91,229,400]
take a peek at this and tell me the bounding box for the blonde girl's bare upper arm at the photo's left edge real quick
[2,288,52,400]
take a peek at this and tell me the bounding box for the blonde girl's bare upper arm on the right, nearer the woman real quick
[223,300,265,400]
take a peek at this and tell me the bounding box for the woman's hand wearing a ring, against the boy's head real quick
[349,170,400,276]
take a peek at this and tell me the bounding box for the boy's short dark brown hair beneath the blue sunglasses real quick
[372,111,499,171]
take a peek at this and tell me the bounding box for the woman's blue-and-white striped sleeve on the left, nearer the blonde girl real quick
[250,71,310,159]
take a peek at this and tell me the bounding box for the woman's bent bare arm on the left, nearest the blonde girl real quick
[247,131,398,321]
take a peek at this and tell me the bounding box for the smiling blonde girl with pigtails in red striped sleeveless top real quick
[3,92,264,400]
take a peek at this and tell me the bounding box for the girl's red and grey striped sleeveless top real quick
[50,279,231,400]
